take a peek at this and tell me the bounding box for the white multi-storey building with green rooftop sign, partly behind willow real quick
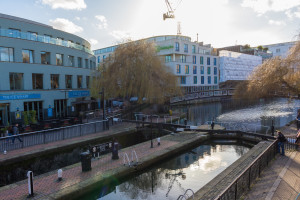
[94,35,219,93]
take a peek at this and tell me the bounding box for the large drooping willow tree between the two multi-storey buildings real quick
[92,41,180,103]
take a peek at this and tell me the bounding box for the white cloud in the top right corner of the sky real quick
[241,0,300,15]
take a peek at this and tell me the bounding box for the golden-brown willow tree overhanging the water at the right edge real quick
[235,42,300,98]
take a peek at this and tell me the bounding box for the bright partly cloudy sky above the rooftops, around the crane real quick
[0,0,300,50]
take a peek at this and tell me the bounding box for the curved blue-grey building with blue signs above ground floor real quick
[0,14,96,126]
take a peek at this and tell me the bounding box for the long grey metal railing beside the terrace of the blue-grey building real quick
[0,119,111,152]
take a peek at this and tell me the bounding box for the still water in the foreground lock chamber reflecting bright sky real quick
[80,141,251,200]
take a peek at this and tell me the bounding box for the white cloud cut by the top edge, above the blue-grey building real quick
[42,0,86,10]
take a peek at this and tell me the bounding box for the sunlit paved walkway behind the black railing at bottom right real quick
[244,122,300,200]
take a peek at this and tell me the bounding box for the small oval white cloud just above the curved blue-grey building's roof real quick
[50,18,83,33]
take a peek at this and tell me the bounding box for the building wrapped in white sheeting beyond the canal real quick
[219,50,262,82]
